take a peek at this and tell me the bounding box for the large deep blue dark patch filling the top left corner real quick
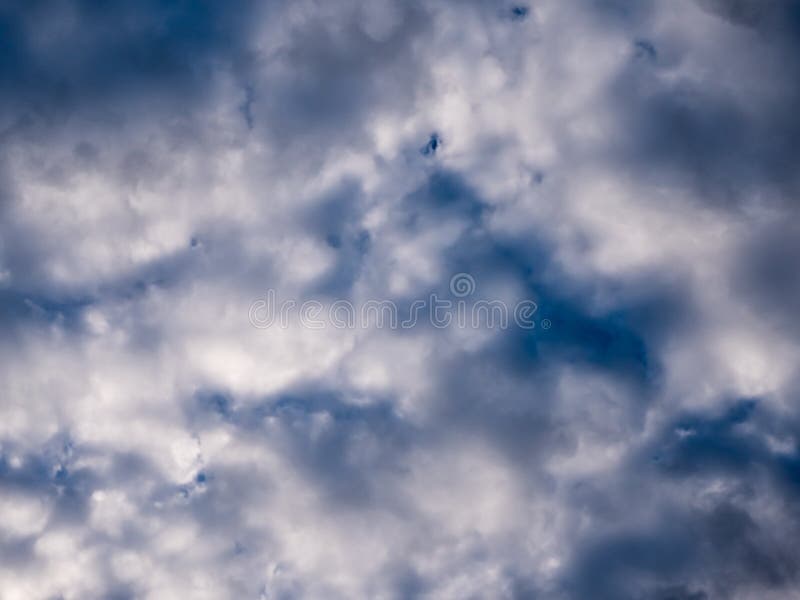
[0,0,254,127]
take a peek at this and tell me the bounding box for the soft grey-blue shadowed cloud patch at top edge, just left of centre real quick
[251,2,429,161]
